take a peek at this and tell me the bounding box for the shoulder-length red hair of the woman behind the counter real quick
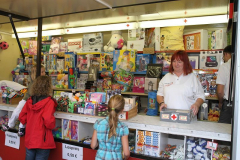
[169,50,193,75]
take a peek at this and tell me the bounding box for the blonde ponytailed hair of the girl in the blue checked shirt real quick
[108,95,125,139]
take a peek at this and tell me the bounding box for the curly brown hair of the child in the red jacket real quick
[30,76,52,96]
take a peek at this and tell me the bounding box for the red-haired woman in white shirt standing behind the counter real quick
[157,50,205,115]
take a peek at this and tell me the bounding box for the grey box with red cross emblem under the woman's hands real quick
[160,108,193,123]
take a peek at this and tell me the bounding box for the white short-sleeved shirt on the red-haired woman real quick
[157,73,205,110]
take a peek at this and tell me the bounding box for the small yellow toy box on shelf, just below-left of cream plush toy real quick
[100,53,113,71]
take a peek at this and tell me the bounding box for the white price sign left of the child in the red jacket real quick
[5,132,20,149]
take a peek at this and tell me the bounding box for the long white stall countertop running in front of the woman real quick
[0,104,231,142]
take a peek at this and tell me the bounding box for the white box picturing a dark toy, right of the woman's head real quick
[200,51,223,69]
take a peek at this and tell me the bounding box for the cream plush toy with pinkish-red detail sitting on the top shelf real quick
[104,31,127,52]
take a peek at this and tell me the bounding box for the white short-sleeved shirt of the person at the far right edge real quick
[216,59,231,100]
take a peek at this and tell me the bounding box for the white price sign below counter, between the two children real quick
[62,143,83,160]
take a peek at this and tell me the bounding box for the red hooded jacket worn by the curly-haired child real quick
[19,97,57,149]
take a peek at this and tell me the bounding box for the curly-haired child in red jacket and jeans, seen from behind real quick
[19,76,57,160]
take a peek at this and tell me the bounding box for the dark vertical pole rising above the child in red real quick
[37,18,42,77]
